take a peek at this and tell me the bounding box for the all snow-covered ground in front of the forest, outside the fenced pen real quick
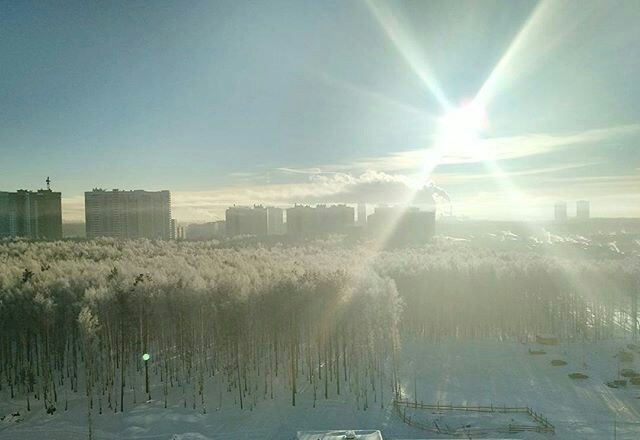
[0,341,640,440]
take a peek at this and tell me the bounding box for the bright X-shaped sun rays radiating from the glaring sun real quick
[356,0,604,278]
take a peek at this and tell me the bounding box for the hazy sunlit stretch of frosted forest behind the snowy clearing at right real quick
[375,245,640,341]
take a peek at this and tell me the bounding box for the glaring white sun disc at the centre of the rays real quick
[438,102,488,160]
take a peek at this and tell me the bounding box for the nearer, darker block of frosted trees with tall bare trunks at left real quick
[0,240,402,434]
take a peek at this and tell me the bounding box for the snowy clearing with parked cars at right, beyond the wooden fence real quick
[403,342,640,439]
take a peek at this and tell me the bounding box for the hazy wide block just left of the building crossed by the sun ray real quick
[287,205,355,236]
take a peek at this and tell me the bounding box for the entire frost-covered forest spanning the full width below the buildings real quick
[0,240,640,434]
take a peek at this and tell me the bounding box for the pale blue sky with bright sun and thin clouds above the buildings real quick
[0,0,640,222]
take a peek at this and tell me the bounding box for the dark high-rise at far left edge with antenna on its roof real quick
[0,189,62,240]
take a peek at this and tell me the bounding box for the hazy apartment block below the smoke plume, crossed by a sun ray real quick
[367,206,436,246]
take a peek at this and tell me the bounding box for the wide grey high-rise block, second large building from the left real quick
[84,189,172,240]
